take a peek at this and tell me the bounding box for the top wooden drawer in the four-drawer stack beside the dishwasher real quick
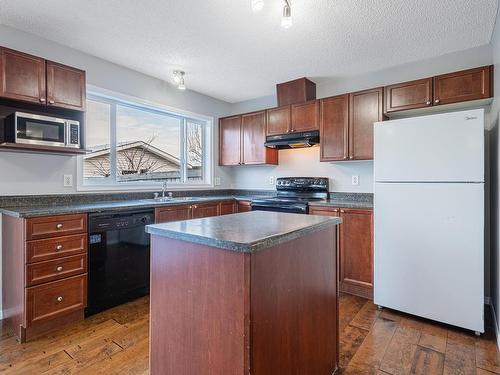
[26,214,87,240]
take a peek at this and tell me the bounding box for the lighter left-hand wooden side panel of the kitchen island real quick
[150,235,250,375]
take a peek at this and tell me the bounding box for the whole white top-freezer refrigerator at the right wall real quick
[374,109,484,333]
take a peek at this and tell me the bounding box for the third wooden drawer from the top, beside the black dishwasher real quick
[26,254,87,286]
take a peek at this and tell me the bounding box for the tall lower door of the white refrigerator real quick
[374,183,484,332]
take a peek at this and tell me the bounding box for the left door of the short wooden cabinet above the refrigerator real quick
[384,78,432,113]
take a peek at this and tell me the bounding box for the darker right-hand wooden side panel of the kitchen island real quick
[250,226,339,375]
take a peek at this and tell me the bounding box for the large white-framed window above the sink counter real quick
[82,94,212,187]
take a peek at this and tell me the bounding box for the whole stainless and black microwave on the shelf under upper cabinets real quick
[0,112,81,148]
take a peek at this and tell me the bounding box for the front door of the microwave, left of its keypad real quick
[15,113,66,147]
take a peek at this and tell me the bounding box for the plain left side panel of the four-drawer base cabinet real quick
[2,215,26,342]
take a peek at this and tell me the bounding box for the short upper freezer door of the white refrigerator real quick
[374,109,484,182]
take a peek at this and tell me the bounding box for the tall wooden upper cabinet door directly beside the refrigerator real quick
[349,87,383,160]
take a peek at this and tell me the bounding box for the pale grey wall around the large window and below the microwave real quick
[0,25,235,195]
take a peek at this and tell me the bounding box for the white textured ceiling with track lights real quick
[0,0,497,102]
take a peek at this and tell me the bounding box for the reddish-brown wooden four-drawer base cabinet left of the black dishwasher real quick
[2,214,87,342]
